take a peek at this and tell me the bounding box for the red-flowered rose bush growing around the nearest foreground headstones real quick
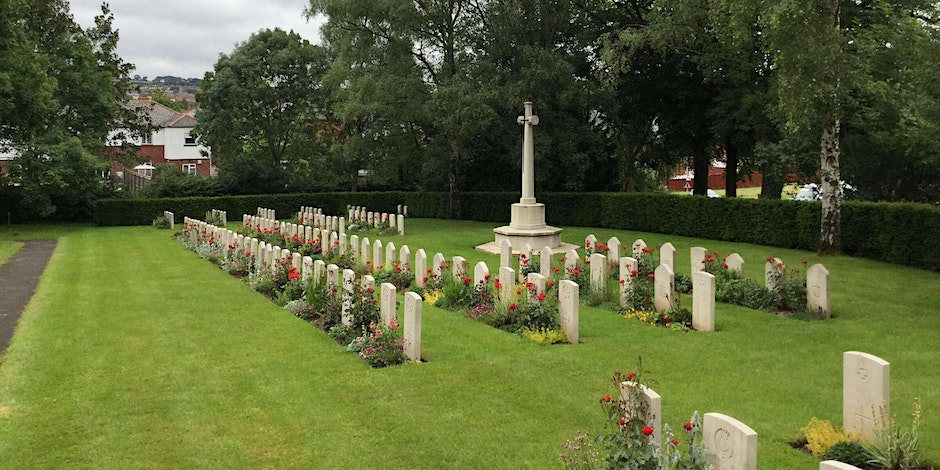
[560,366,711,470]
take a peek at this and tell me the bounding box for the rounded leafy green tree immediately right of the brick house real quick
[193,29,331,192]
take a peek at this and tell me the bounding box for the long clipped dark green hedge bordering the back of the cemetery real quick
[96,192,940,271]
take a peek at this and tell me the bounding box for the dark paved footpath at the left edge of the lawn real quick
[0,240,56,353]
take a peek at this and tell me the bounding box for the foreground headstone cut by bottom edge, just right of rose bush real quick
[702,413,757,470]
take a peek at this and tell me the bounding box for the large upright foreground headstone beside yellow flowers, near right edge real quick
[842,351,891,442]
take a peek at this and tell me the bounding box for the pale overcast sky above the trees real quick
[70,0,324,79]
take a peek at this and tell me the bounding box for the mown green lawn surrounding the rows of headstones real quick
[0,219,940,469]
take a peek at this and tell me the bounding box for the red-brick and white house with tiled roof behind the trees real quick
[108,98,215,179]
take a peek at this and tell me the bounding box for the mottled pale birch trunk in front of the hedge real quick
[819,117,842,253]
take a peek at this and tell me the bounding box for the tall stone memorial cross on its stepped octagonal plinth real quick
[477,101,577,254]
